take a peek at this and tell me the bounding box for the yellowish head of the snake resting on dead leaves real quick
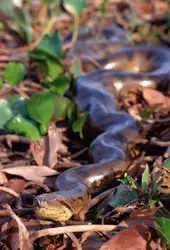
[33,192,73,222]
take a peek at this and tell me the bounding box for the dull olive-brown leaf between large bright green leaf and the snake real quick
[52,96,71,121]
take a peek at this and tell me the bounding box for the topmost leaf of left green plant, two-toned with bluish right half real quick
[36,30,63,59]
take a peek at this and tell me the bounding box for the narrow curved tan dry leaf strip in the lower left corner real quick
[6,205,33,250]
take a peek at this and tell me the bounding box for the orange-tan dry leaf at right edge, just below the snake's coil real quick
[142,88,170,114]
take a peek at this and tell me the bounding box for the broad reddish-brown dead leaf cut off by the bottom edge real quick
[100,224,151,250]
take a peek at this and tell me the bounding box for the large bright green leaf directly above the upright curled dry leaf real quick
[26,91,54,125]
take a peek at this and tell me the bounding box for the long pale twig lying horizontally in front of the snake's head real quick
[30,225,117,243]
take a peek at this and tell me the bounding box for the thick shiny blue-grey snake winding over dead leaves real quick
[34,45,170,222]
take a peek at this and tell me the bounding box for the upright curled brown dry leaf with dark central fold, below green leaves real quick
[31,124,66,168]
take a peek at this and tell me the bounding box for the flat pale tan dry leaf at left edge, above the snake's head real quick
[0,166,59,182]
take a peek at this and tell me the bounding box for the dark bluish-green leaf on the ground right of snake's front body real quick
[108,184,139,208]
